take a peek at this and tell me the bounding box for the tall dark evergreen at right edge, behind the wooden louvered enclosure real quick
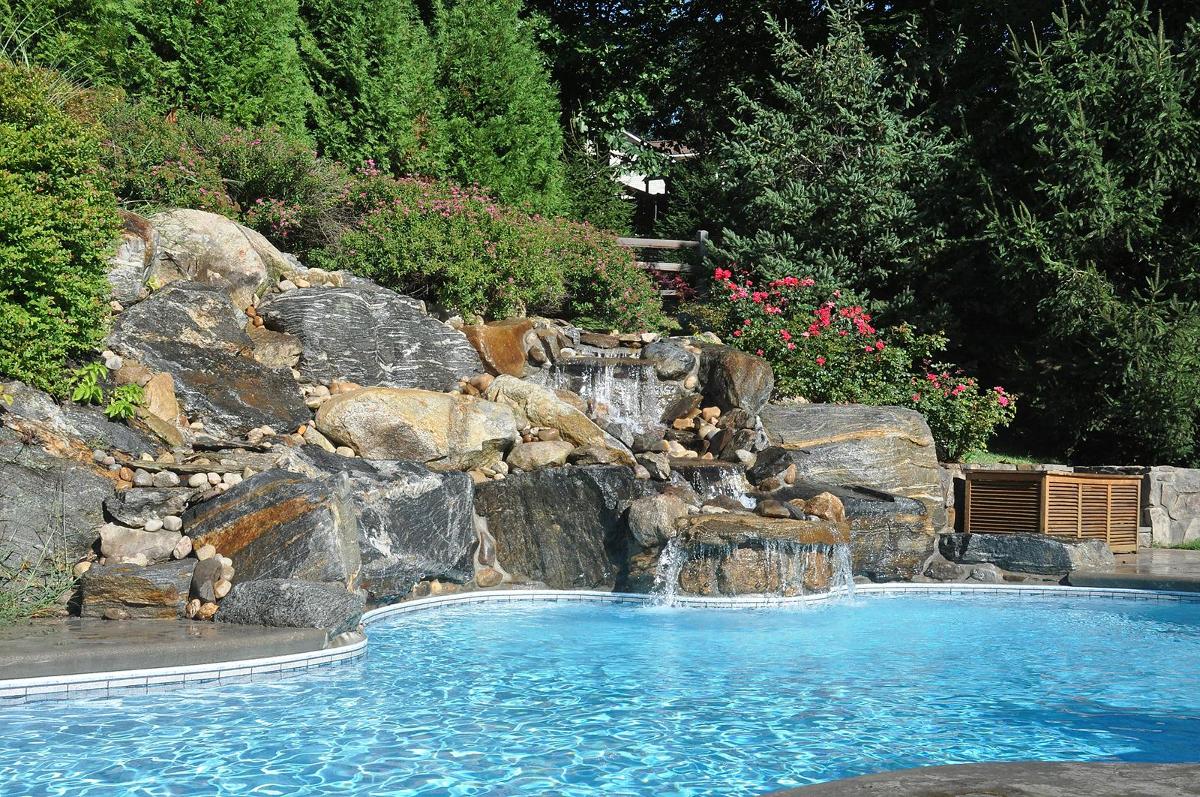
[985,0,1200,462]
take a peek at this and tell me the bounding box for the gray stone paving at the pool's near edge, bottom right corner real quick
[767,762,1200,797]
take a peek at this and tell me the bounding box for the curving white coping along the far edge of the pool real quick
[0,583,1200,708]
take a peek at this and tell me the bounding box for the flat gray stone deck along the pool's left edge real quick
[0,618,325,681]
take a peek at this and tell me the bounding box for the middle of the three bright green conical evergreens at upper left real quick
[300,0,445,174]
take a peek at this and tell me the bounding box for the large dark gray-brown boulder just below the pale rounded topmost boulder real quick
[109,282,311,437]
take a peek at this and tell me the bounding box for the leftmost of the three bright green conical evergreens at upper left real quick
[125,0,312,132]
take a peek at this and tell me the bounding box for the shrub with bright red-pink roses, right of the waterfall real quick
[713,269,1016,461]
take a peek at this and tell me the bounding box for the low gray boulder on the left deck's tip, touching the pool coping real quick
[216,579,364,639]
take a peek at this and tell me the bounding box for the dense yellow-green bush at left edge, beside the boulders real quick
[0,60,119,394]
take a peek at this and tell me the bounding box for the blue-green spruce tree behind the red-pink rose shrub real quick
[713,12,954,309]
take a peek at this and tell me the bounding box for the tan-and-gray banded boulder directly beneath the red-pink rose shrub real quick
[761,403,946,531]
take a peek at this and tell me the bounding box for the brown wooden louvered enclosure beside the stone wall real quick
[962,471,1141,553]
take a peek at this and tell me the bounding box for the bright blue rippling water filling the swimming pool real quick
[7,595,1200,797]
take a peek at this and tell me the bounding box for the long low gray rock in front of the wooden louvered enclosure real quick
[937,534,1116,575]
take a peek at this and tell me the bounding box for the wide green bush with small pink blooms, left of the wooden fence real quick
[310,176,662,328]
